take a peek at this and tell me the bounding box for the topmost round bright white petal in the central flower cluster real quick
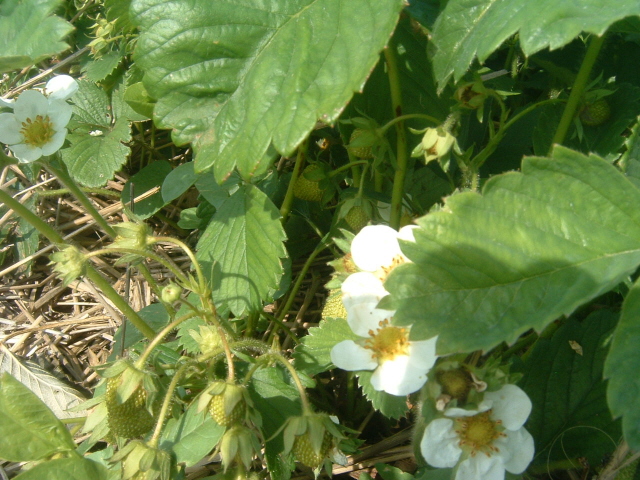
[351,225,402,272]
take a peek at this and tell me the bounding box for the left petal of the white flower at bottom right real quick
[420,418,462,468]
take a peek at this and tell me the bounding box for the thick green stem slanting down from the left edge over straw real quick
[0,186,156,340]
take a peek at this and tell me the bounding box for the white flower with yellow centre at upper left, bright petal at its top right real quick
[0,75,78,163]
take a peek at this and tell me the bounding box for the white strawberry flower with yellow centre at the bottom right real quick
[420,385,535,480]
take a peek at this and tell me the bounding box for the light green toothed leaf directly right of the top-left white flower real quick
[60,81,131,187]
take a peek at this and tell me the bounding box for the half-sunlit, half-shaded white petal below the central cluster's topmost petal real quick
[342,272,394,337]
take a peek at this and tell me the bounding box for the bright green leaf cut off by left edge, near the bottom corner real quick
[0,373,75,462]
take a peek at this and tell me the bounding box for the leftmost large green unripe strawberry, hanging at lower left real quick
[106,377,155,438]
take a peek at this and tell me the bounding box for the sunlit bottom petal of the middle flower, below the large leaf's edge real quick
[371,355,429,396]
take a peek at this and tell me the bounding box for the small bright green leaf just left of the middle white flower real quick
[293,318,360,375]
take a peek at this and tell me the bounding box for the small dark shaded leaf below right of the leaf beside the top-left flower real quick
[122,160,172,219]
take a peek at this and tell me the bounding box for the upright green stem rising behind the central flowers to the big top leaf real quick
[384,41,408,230]
